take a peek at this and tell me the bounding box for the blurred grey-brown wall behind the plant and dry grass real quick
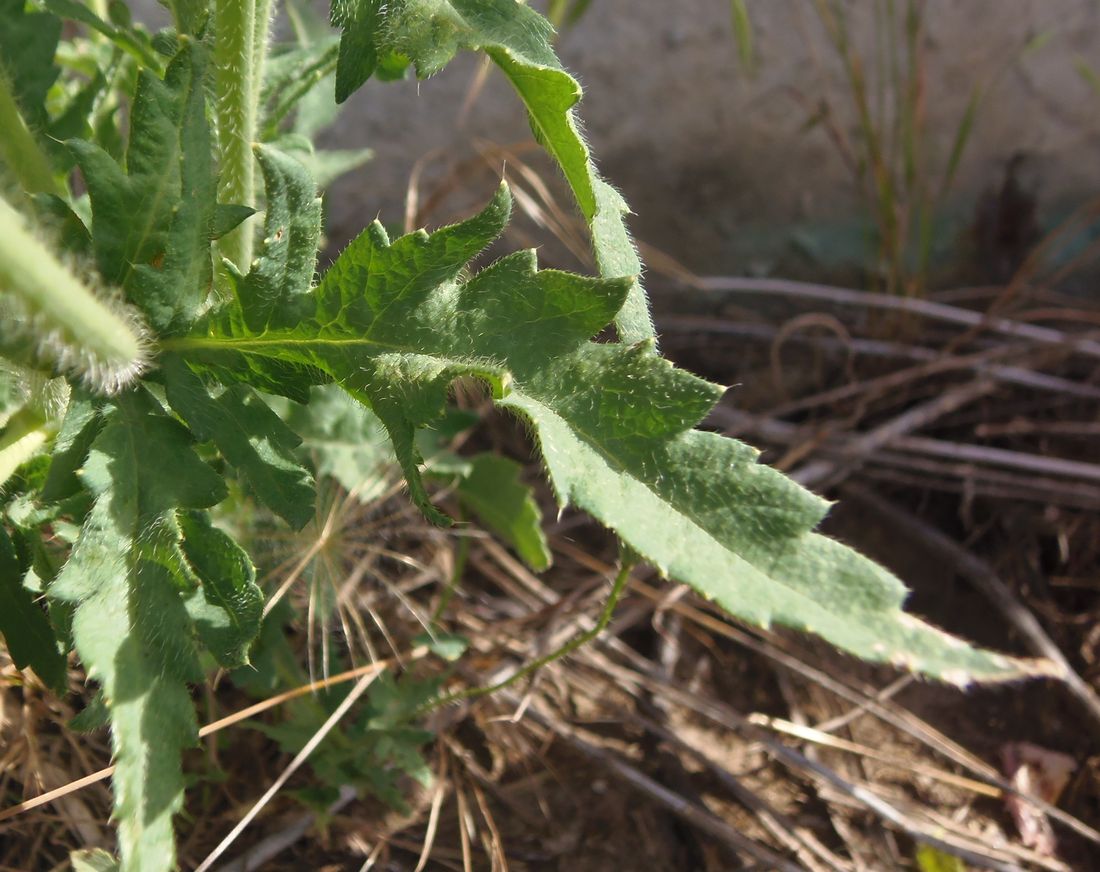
[327,0,1100,288]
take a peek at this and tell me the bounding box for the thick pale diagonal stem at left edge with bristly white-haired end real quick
[0,198,145,393]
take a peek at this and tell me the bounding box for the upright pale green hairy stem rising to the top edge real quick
[213,0,272,272]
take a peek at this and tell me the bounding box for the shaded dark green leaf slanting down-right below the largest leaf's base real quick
[163,356,316,530]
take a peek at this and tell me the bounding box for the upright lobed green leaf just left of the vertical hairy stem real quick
[68,40,216,332]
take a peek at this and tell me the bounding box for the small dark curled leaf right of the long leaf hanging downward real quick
[178,511,264,669]
